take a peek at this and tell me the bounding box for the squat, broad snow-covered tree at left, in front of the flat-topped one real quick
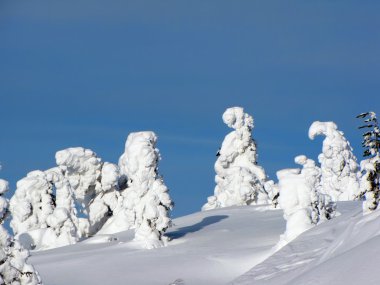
[10,167,80,249]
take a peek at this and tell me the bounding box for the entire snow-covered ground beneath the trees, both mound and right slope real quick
[31,202,380,285]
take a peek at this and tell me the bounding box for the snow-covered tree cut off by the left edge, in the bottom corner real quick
[0,179,42,285]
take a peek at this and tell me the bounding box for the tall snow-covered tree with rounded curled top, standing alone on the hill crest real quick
[202,107,268,210]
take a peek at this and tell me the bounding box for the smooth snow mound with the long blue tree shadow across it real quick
[31,206,285,285]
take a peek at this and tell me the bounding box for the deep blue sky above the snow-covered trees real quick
[0,0,380,216]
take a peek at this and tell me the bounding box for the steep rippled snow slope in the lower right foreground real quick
[231,202,380,285]
